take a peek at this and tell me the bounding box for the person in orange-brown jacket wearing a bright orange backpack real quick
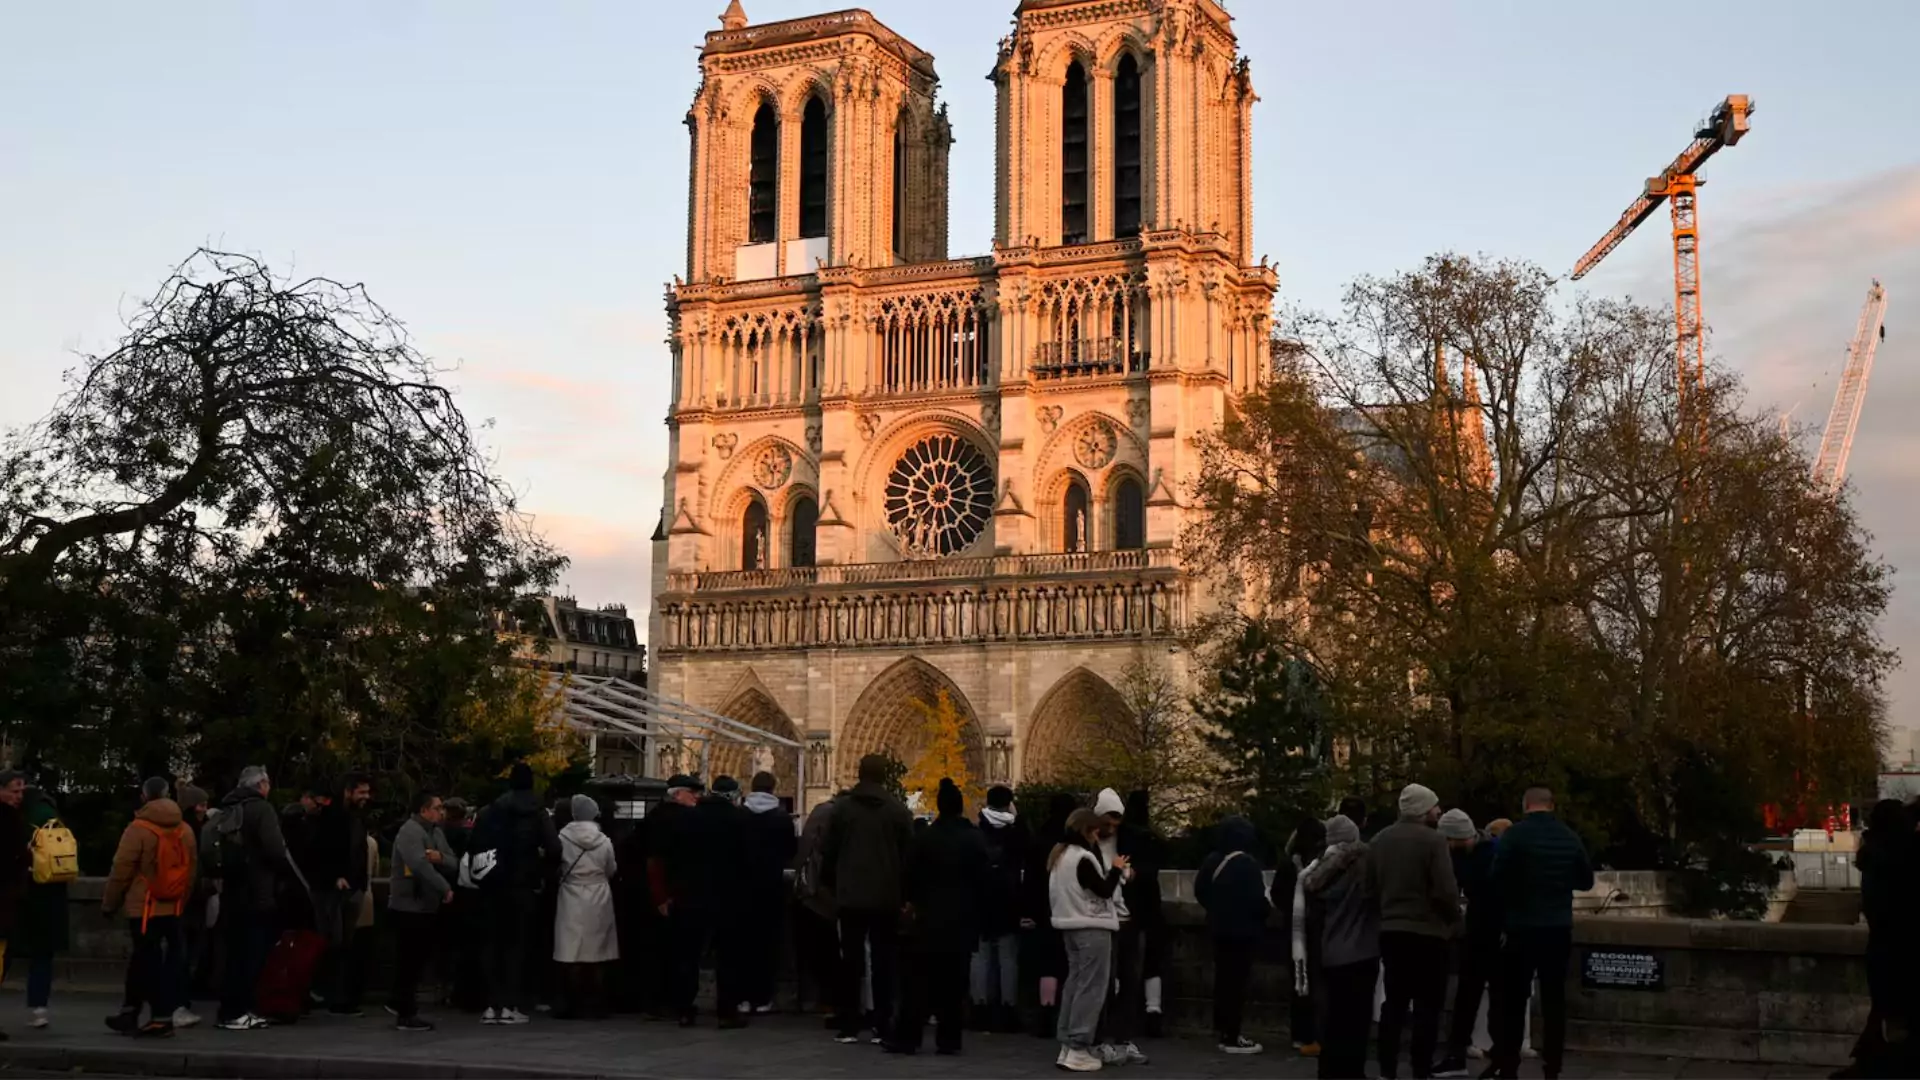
[100,776,200,1038]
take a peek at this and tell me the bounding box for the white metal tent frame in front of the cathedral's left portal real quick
[547,671,806,792]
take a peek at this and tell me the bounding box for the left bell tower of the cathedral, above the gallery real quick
[687,0,952,282]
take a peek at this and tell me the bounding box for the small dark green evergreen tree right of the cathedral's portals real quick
[1194,623,1331,842]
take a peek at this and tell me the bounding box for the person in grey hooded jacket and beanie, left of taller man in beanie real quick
[1296,815,1380,1080]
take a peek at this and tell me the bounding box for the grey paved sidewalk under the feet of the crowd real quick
[0,994,1828,1080]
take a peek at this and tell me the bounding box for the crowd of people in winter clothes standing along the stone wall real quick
[0,757,1643,1076]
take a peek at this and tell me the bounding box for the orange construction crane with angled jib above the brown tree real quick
[1572,94,1753,402]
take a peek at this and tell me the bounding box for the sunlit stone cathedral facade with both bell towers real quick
[649,0,1277,805]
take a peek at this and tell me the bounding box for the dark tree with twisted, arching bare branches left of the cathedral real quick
[0,250,564,799]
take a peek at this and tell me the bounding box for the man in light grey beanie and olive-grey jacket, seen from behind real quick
[1367,784,1459,1078]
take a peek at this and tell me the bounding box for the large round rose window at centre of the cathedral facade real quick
[885,434,993,555]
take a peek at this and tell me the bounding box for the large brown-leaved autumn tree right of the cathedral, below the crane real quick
[1183,256,1895,859]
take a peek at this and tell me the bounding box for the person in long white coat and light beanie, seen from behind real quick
[553,796,620,1019]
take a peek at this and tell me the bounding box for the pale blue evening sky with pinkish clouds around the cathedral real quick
[0,0,1920,724]
